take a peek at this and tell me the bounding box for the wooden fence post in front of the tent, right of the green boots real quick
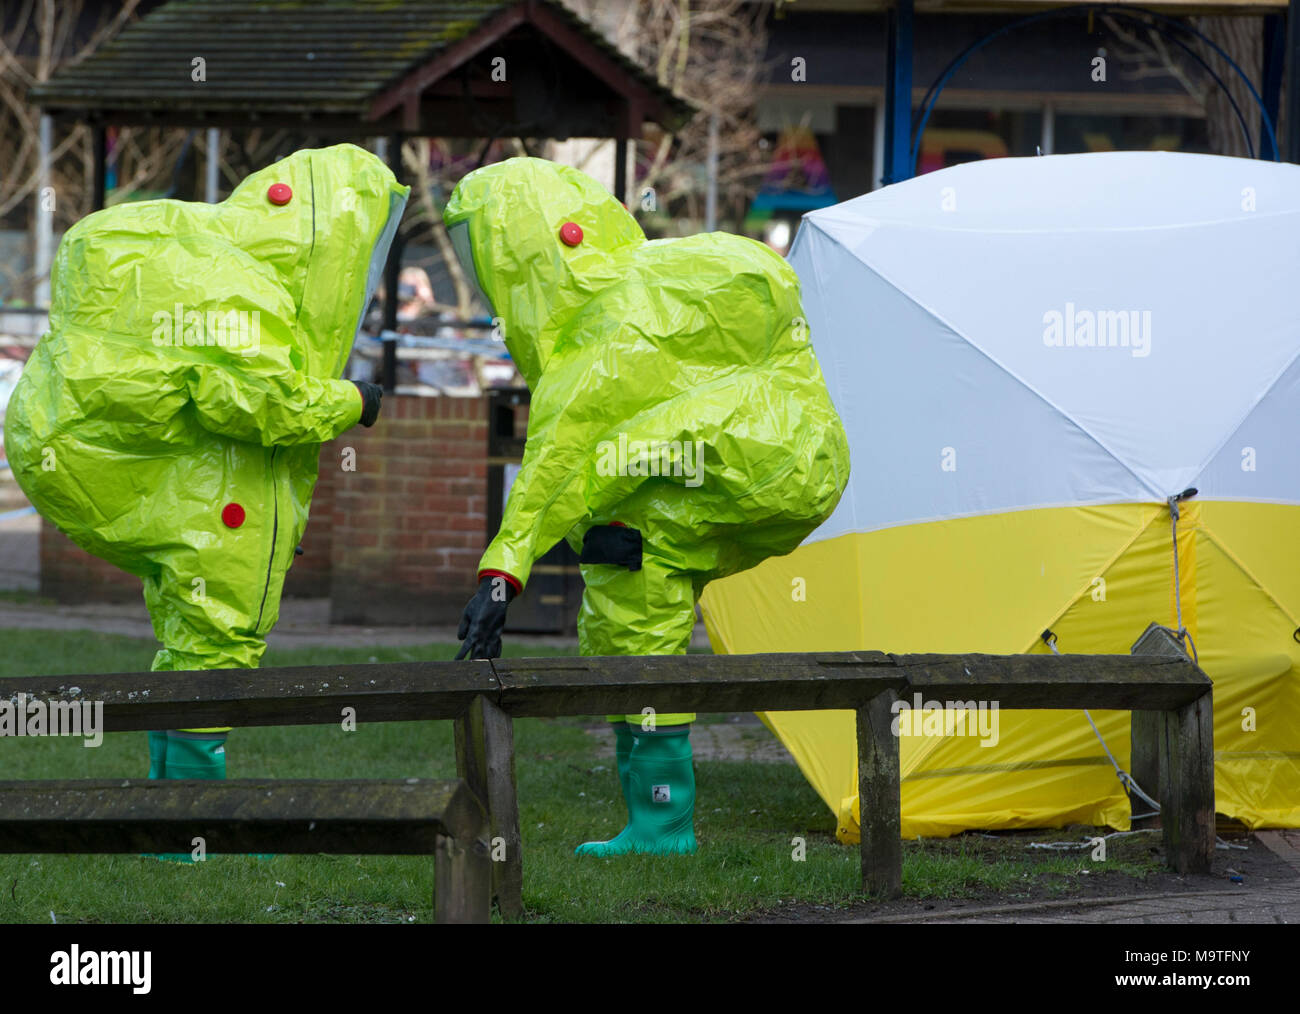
[858,690,902,900]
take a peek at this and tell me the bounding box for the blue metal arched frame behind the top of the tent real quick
[885,0,1279,183]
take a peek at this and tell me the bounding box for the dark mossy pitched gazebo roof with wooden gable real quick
[29,0,693,138]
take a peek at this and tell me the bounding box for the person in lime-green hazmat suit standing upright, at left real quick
[5,144,407,816]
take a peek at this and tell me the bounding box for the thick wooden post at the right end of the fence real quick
[1132,624,1214,874]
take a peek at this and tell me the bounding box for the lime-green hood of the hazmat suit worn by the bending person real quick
[443,159,646,387]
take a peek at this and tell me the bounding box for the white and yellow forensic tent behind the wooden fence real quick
[702,152,1300,841]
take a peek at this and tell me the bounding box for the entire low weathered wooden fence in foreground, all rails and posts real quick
[0,624,1214,922]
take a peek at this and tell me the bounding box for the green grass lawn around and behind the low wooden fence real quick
[0,631,1156,923]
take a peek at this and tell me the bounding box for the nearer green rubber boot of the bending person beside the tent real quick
[575,725,697,855]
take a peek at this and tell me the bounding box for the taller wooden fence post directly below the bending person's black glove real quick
[455,697,524,919]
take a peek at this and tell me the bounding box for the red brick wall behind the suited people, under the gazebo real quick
[40,397,488,625]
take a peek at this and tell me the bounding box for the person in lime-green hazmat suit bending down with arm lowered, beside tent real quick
[443,159,849,855]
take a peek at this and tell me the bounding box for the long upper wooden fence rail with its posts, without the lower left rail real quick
[0,624,1214,918]
